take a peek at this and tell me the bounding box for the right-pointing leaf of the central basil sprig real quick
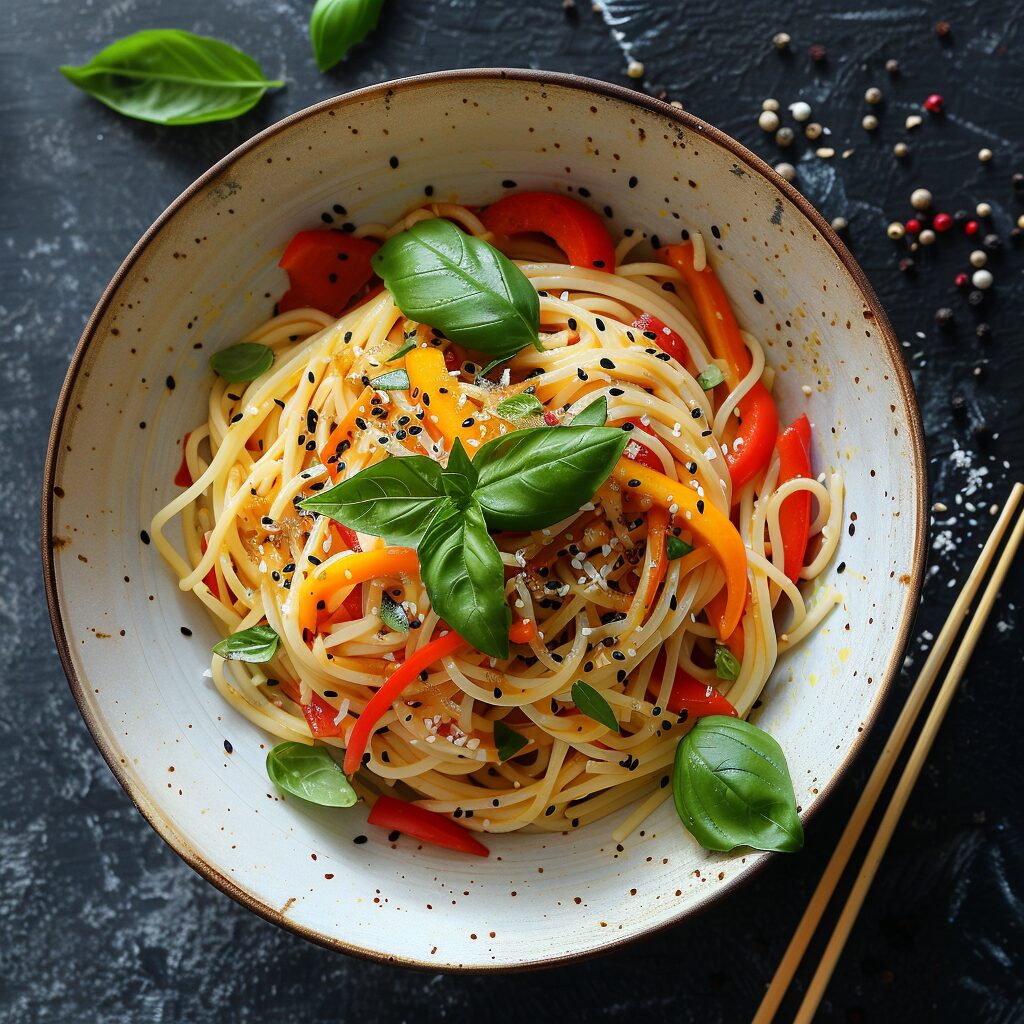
[473,426,629,530]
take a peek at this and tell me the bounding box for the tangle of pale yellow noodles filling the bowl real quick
[152,204,843,840]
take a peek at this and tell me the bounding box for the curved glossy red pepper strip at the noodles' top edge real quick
[480,193,615,273]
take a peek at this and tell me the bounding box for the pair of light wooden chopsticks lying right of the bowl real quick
[753,483,1024,1024]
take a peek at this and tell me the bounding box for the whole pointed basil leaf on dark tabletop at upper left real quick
[60,29,285,125]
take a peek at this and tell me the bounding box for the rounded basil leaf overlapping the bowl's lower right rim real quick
[672,715,804,852]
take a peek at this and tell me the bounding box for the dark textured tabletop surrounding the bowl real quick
[0,0,1024,1024]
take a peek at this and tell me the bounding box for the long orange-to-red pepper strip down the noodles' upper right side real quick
[658,242,778,493]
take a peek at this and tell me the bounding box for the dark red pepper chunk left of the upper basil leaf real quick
[278,230,379,316]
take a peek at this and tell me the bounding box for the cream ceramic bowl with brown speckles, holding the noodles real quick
[43,71,926,970]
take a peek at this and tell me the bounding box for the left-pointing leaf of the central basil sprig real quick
[299,455,445,547]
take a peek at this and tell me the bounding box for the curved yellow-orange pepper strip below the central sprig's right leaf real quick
[611,459,746,639]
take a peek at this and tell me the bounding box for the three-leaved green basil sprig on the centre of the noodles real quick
[300,426,628,658]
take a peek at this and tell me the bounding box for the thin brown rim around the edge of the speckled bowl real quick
[42,68,928,974]
